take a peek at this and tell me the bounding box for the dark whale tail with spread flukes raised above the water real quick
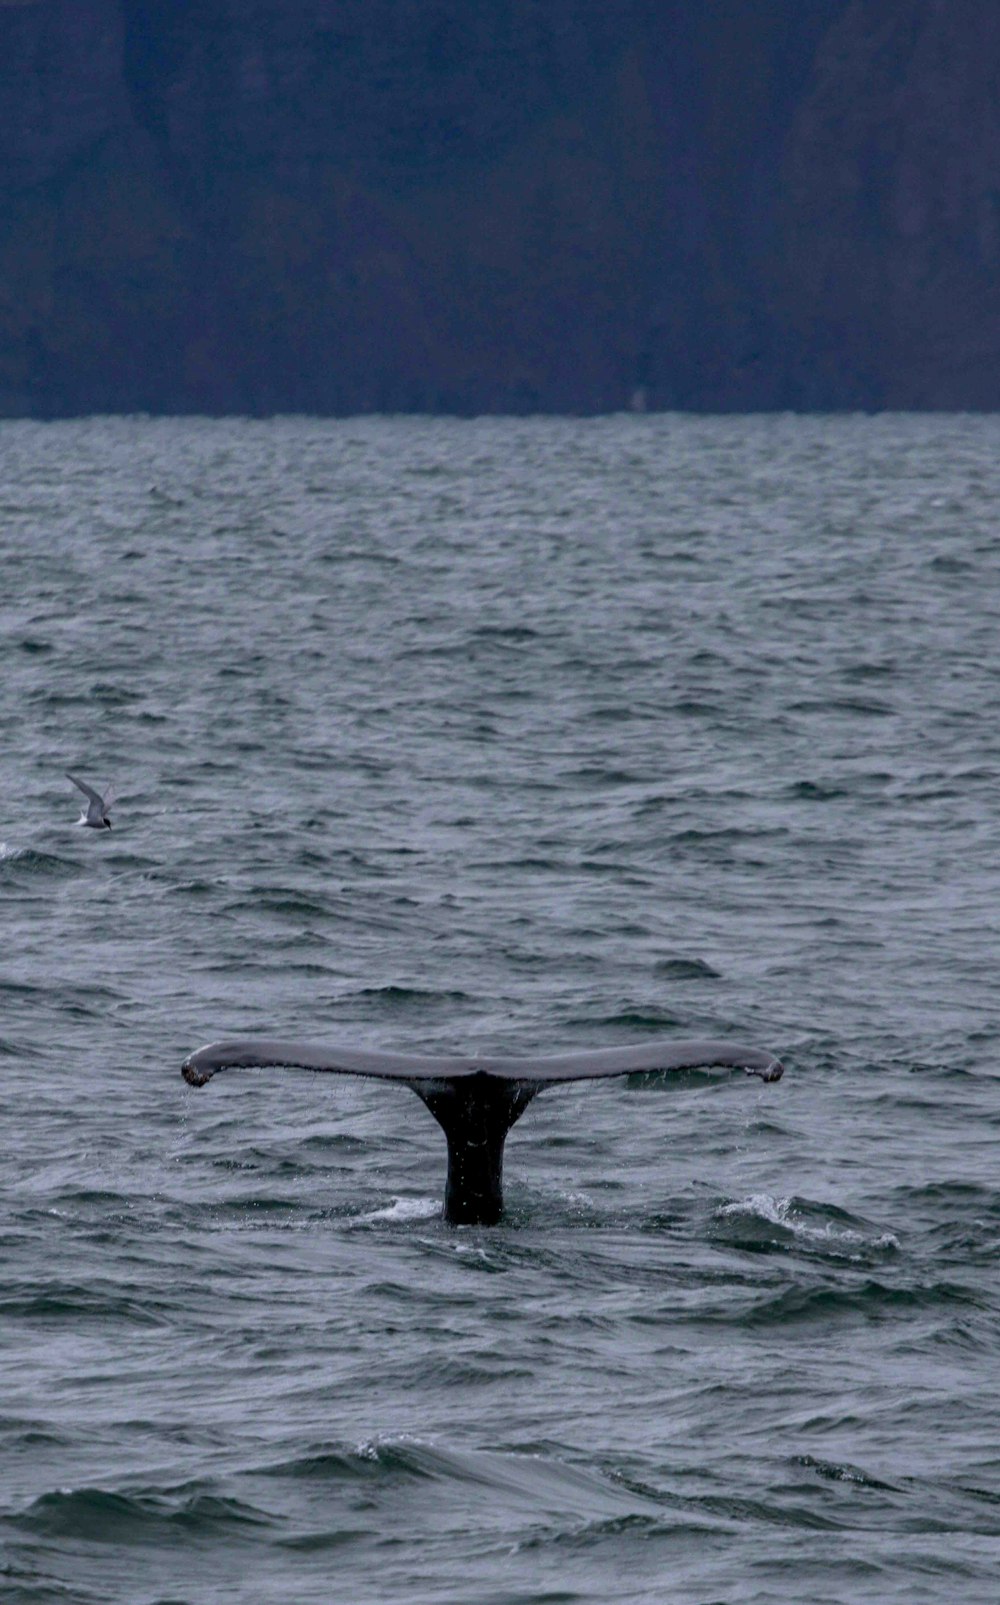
[181,1037,783,1226]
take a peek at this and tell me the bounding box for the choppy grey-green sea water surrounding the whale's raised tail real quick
[0,416,1000,1605]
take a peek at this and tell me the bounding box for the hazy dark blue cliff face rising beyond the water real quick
[0,0,1000,416]
